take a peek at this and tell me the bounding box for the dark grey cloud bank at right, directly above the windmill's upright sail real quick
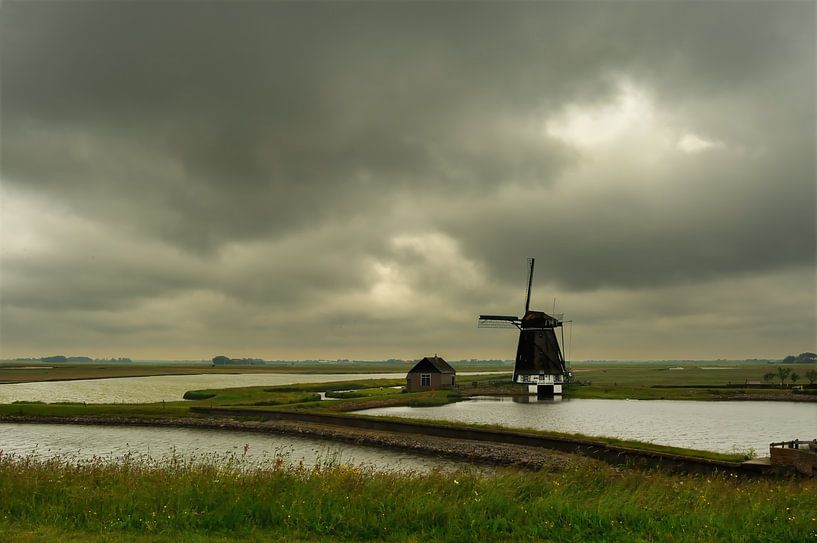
[445,138,815,289]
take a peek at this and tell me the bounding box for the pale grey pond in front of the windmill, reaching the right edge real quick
[358,398,817,456]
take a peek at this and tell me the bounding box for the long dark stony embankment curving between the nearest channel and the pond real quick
[0,407,772,475]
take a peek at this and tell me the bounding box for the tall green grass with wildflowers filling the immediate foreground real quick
[0,456,817,542]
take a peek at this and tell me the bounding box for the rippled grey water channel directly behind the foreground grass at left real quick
[0,423,464,472]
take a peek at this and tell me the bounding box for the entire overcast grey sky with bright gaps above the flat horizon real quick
[0,0,817,360]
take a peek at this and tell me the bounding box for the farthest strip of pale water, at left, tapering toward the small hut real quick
[0,373,406,403]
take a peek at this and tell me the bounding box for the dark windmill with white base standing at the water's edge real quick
[478,258,568,396]
